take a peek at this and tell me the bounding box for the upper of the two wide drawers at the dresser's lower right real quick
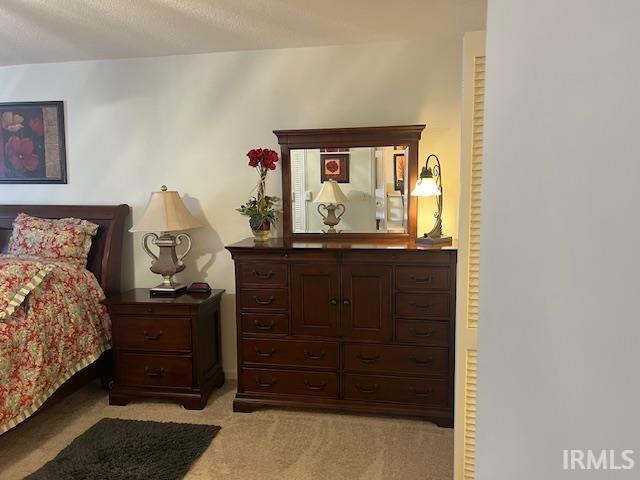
[344,343,449,376]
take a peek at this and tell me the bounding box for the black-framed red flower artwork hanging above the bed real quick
[0,102,67,183]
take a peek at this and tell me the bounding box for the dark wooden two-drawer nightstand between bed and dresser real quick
[106,289,224,410]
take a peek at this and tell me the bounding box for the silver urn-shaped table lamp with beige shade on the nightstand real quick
[129,185,202,296]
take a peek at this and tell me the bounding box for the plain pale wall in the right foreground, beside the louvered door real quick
[477,0,640,480]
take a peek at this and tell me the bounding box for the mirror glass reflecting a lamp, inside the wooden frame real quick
[290,145,409,233]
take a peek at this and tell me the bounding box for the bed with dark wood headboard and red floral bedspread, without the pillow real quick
[0,205,129,435]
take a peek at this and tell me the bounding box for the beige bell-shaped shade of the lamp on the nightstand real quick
[129,185,202,232]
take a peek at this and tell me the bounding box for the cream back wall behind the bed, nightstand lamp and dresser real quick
[0,37,464,375]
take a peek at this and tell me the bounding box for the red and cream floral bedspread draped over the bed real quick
[0,255,111,434]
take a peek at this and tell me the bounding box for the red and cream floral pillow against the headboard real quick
[9,213,98,268]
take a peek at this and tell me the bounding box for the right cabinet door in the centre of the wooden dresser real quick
[341,265,393,341]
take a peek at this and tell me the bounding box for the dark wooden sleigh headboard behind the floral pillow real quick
[0,205,129,295]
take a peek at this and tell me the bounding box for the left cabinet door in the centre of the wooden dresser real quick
[290,264,340,337]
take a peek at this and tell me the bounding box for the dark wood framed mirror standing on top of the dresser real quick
[273,125,425,241]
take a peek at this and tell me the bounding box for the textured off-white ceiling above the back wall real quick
[0,0,486,65]
